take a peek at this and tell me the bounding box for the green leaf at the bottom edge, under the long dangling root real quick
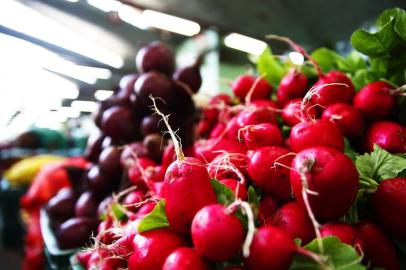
[290,236,366,270]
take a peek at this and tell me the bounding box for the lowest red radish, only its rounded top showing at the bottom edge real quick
[162,247,210,270]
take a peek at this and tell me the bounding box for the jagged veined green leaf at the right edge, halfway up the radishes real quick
[355,145,406,181]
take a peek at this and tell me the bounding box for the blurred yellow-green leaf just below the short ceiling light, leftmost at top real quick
[257,47,288,87]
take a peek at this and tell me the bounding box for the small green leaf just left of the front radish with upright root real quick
[138,200,169,233]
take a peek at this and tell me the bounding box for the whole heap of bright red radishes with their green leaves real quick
[50,9,406,270]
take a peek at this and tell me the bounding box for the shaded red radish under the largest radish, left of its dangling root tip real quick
[270,202,315,244]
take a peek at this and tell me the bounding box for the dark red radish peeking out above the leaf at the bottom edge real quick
[320,222,364,250]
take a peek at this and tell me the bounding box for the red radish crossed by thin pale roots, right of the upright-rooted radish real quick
[208,153,248,180]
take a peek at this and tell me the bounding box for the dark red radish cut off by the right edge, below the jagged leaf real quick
[372,177,406,240]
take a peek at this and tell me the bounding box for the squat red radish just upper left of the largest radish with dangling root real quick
[240,123,284,150]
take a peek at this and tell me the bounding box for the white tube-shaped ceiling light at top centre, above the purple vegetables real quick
[141,10,200,36]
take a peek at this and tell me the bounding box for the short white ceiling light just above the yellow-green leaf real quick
[224,33,266,55]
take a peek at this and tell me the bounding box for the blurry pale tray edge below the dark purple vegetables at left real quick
[40,209,79,270]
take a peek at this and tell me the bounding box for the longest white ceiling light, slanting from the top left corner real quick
[0,1,124,68]
